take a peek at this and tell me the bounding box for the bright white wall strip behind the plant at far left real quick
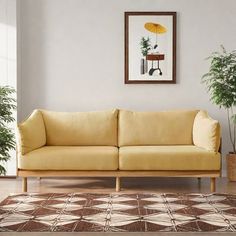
[0,0,17,175]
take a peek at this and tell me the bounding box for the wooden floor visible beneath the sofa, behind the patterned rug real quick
[0,178,236,200]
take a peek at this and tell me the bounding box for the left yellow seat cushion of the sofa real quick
[18,146,118,170]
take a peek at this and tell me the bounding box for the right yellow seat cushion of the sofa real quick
[119,145,221,171]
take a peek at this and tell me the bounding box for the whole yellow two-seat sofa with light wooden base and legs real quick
[18,110,221,191]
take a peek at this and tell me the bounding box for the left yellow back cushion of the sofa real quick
[42,110,118,146]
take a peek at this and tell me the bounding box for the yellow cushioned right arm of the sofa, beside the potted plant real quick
[193,111,220,152]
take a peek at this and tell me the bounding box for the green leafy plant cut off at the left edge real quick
[0,86,16,175]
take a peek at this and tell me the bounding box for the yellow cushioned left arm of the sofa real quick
[17,110,46,155]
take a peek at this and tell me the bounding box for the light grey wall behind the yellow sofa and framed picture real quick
[18,0,236,175]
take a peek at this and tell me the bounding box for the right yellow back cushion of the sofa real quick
[119,110,198,146]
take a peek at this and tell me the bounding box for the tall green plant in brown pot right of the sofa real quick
[202,46,236,181]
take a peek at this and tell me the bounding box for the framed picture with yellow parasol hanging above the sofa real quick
[125,12,176,84]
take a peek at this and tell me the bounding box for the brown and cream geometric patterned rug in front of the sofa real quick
[0,193,236,232]
